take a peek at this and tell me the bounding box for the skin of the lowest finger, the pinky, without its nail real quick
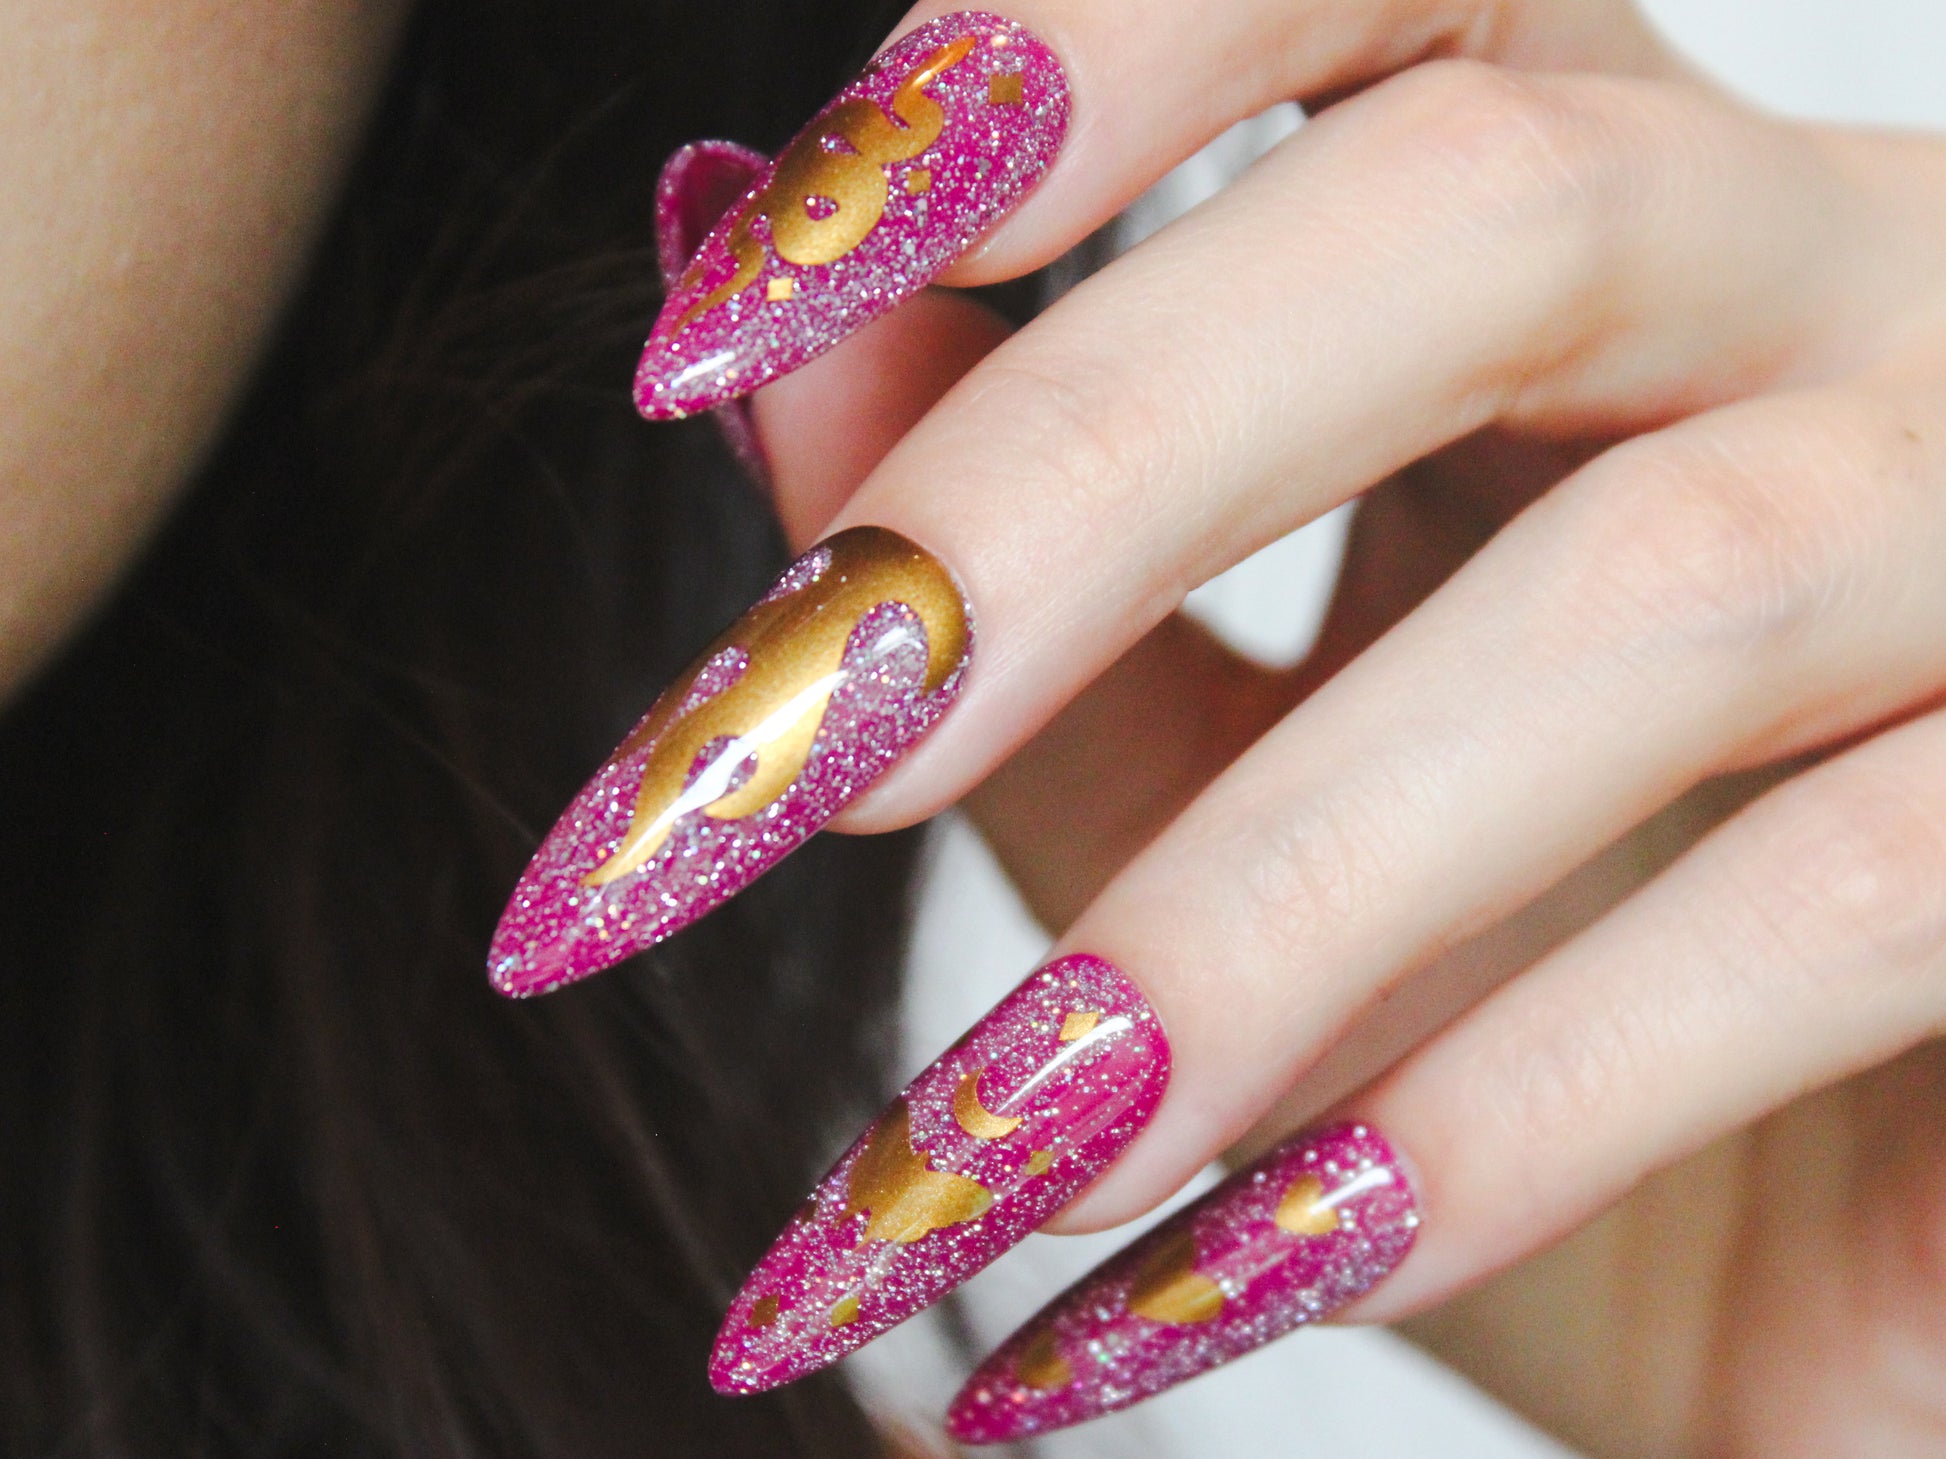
[1360,712,1946,1321]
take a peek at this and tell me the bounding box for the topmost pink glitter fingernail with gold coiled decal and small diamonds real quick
[634,10,1068,420]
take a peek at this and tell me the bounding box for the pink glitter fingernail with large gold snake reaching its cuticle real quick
[488,527,973,998]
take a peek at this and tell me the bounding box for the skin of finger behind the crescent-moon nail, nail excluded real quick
[1061,370,1946,1229]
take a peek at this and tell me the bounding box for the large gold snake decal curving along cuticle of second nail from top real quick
[582,527,967,887]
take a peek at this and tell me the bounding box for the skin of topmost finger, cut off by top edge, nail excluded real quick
[887,0,1679,284]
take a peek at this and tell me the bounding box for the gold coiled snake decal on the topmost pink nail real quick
[675,35,977,331]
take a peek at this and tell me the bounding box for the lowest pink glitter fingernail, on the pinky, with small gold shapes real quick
[946,1124,1419,1443]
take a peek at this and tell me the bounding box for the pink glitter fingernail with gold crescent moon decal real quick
[710,955,1170,1393]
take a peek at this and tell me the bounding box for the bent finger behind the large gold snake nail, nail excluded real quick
[835,66,1919,829]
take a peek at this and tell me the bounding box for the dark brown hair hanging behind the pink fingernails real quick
[0,0,913,1459]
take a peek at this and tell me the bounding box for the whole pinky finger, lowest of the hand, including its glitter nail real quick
[950,712,1946,1443]
